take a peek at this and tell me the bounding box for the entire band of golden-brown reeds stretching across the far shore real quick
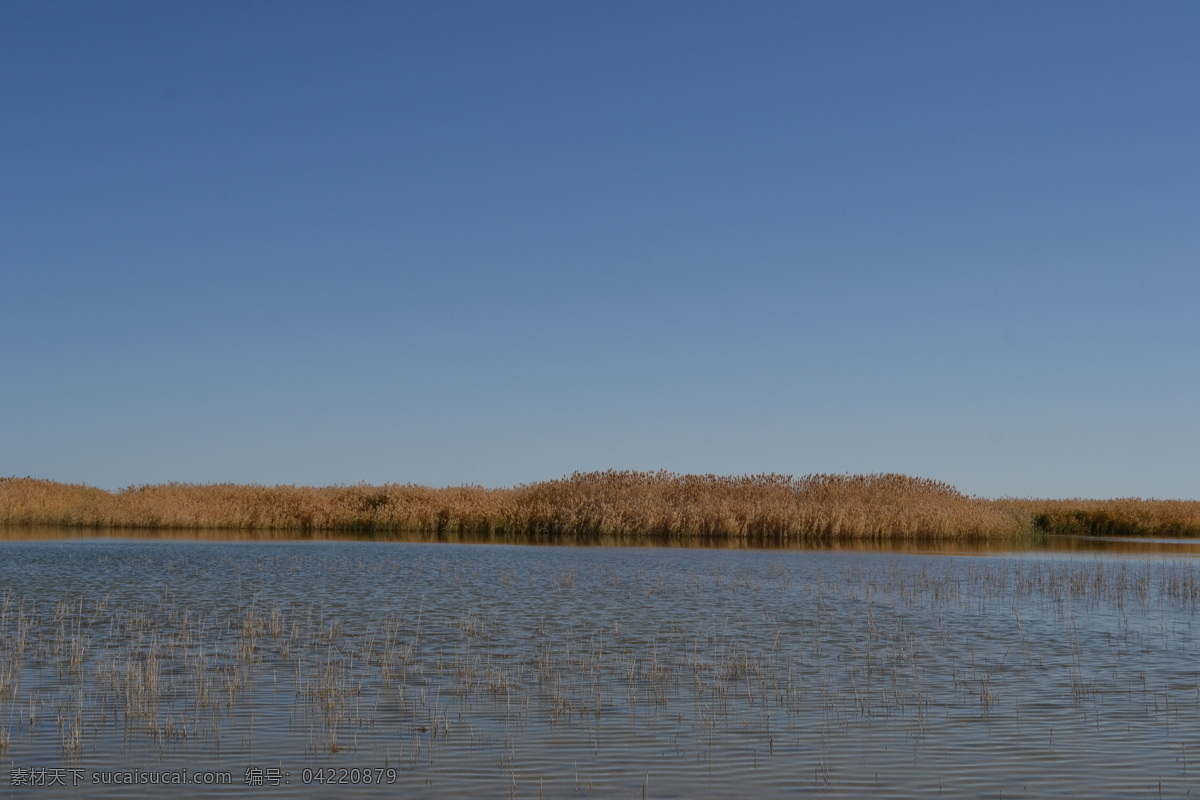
[0,470,1200,543]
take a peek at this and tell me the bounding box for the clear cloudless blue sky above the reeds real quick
[0,0,1200,498]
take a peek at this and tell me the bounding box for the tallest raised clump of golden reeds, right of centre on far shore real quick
[515,470,1022,541]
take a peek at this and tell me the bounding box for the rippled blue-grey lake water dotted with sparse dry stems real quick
[0,531,1200,799]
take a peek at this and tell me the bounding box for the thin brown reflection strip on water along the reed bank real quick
[0,525,1200,555]
